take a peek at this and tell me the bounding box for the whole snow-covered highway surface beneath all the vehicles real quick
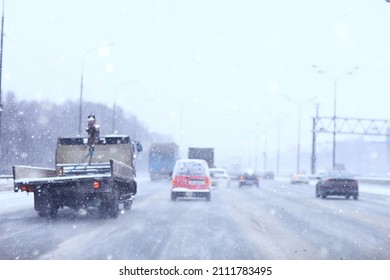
[0,176,390,260]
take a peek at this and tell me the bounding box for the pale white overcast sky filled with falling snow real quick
[2,0,390,170]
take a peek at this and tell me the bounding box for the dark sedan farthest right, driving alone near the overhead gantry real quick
[316,170,359,200]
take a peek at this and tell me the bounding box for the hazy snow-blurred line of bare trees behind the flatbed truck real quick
[0,92,172,174]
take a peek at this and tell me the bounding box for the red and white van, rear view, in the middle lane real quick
[171,159,211,201]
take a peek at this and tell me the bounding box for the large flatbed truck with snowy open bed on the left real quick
[12,136,137,218]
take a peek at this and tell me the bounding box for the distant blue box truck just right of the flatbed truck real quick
[148,143,179,181]
